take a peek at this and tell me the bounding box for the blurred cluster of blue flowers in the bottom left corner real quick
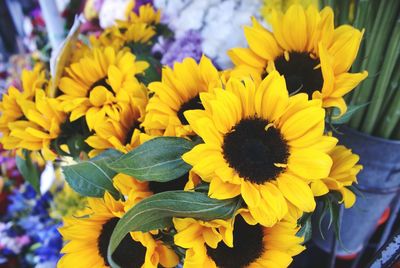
[0,184,62,267]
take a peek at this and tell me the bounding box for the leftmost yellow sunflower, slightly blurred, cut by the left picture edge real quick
[0,64,66,160]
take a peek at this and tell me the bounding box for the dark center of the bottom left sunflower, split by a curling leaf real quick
[98,218,146,268]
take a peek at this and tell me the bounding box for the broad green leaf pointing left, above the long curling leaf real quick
[109,137,195,182]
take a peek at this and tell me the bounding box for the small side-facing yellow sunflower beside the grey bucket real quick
[311,145,362,208]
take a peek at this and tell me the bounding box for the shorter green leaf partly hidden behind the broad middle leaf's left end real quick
[63,150,122,199]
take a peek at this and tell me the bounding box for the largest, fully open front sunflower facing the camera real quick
[182,71,336,226]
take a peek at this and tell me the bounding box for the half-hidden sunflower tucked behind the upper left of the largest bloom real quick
[142,56,221,137]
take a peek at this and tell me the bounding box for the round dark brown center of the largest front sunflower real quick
[222,118,289,184]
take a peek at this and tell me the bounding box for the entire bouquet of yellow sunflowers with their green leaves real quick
[0,2,367,267]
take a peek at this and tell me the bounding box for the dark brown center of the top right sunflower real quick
[275,52,324,99]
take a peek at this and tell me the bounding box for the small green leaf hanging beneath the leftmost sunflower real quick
[16,150,40,193]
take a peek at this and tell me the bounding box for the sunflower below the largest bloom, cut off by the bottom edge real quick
[173,215,304,268]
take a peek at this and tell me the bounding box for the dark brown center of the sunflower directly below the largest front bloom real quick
[207,216,265,268]
